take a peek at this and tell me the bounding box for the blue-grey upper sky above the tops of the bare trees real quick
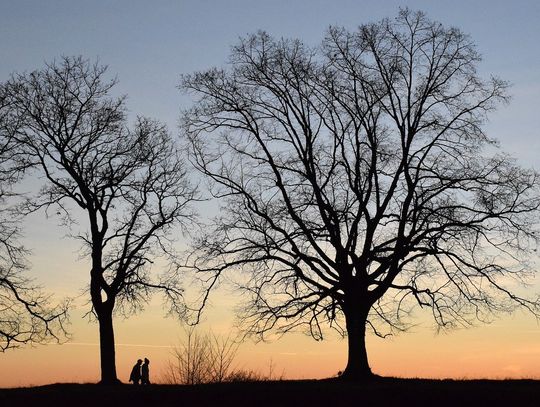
[0,0,540,168]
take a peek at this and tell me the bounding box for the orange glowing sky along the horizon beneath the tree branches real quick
[0,298,540,388]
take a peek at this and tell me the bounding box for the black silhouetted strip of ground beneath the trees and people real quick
[0,378,540,407]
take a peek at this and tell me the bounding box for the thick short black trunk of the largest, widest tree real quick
[341,307,373,381]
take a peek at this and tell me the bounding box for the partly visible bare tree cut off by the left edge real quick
[0,88,69,352]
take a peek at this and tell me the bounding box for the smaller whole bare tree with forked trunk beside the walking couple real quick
[1,57,196,383]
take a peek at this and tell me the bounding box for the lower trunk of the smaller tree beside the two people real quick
[98,307,120,384]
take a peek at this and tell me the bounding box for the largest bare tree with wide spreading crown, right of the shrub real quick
[180,10,539,380]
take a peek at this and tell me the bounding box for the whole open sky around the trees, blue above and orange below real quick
[0,0,540,387]
